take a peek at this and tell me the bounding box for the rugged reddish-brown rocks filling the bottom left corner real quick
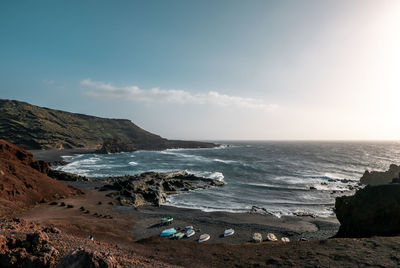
[0,218,120,268]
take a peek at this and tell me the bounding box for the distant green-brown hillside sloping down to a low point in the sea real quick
[0,99,215,152]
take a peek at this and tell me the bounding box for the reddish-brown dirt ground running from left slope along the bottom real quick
[20,190,400,267]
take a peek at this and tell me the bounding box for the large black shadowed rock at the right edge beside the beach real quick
[335,184,400,237]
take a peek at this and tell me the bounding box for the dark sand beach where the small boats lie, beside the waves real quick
[68,181,339,244]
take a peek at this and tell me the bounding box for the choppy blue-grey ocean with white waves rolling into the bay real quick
[56,142,400,217]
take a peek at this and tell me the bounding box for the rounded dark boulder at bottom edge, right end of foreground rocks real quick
[56,249,120,268]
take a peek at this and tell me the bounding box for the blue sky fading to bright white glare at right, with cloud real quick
[0,0,400,140]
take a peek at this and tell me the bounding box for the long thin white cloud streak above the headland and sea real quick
[81,79,278,110]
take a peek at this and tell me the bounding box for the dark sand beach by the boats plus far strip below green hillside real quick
[30,149,339,239]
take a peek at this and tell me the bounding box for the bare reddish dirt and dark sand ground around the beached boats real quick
[5,148,400,267]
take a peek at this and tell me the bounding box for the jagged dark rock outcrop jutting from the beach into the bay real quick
[100,171,224,207]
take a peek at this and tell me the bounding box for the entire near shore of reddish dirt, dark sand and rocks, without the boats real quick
[0,140,400,267]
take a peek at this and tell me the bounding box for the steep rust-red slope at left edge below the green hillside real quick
[0,140,80,217]
